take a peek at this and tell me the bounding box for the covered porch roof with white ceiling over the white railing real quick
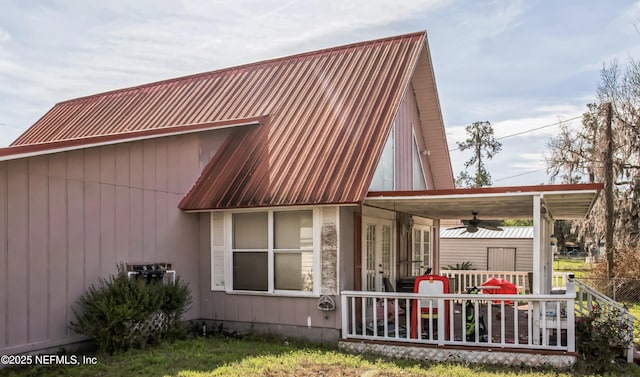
[364,183,603,220]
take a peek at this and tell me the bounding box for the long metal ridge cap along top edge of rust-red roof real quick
[56,30,427,105]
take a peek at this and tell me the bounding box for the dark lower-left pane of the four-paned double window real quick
[233,252,269,291]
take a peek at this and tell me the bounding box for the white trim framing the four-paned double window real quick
[224,207,322,297]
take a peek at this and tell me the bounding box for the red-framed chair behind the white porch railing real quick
[411,275,449,339]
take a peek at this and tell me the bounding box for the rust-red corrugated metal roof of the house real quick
[12,32,430,210]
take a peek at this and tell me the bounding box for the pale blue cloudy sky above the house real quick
[0,0,640,186]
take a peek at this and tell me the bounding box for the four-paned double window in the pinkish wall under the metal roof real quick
[232,210,315,292]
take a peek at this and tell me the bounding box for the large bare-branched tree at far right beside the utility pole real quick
[546,60,640,277]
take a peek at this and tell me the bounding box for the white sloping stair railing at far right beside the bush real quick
[576,281,636,363]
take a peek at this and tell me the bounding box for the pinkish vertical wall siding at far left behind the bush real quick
[0,130,227,353]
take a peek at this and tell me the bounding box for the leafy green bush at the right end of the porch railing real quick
[576,304,633,374]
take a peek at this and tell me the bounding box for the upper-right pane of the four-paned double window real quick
[273,211,313,250]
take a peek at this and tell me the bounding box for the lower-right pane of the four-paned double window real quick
[274,253,313,292]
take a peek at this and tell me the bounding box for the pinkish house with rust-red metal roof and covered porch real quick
[0,32,616,366]
